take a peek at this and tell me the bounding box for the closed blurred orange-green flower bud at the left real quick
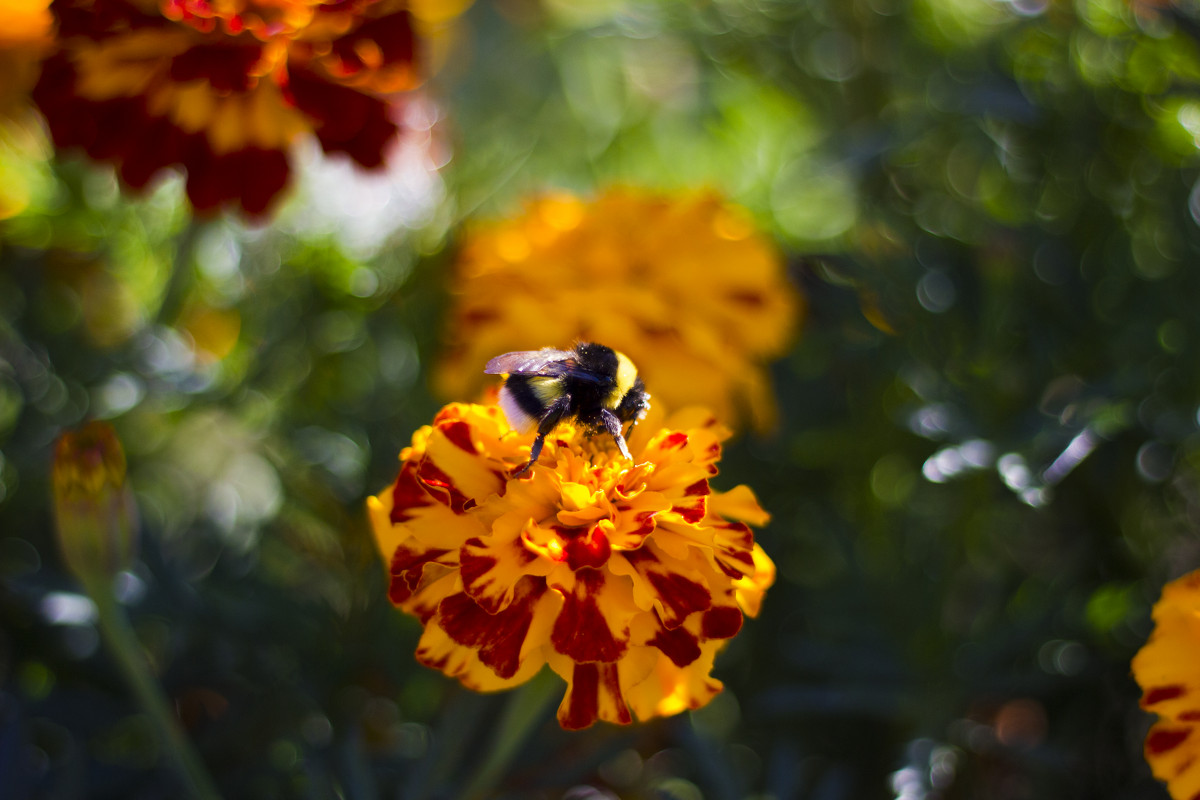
[53,421,137,583]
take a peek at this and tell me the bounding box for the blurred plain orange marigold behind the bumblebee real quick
[437,188,802,429]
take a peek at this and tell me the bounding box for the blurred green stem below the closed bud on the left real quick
[85,578,221,800]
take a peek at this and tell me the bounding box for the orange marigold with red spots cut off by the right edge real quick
[1133,570,1200,800]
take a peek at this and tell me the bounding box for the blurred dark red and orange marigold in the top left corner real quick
[34,0,461,215]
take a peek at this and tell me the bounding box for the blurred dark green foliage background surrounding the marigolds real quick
[0,0,1200,800]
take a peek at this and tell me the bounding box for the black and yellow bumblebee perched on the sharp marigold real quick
[484,342,650,477]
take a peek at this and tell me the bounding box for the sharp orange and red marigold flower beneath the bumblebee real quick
[367,403,775,728]
